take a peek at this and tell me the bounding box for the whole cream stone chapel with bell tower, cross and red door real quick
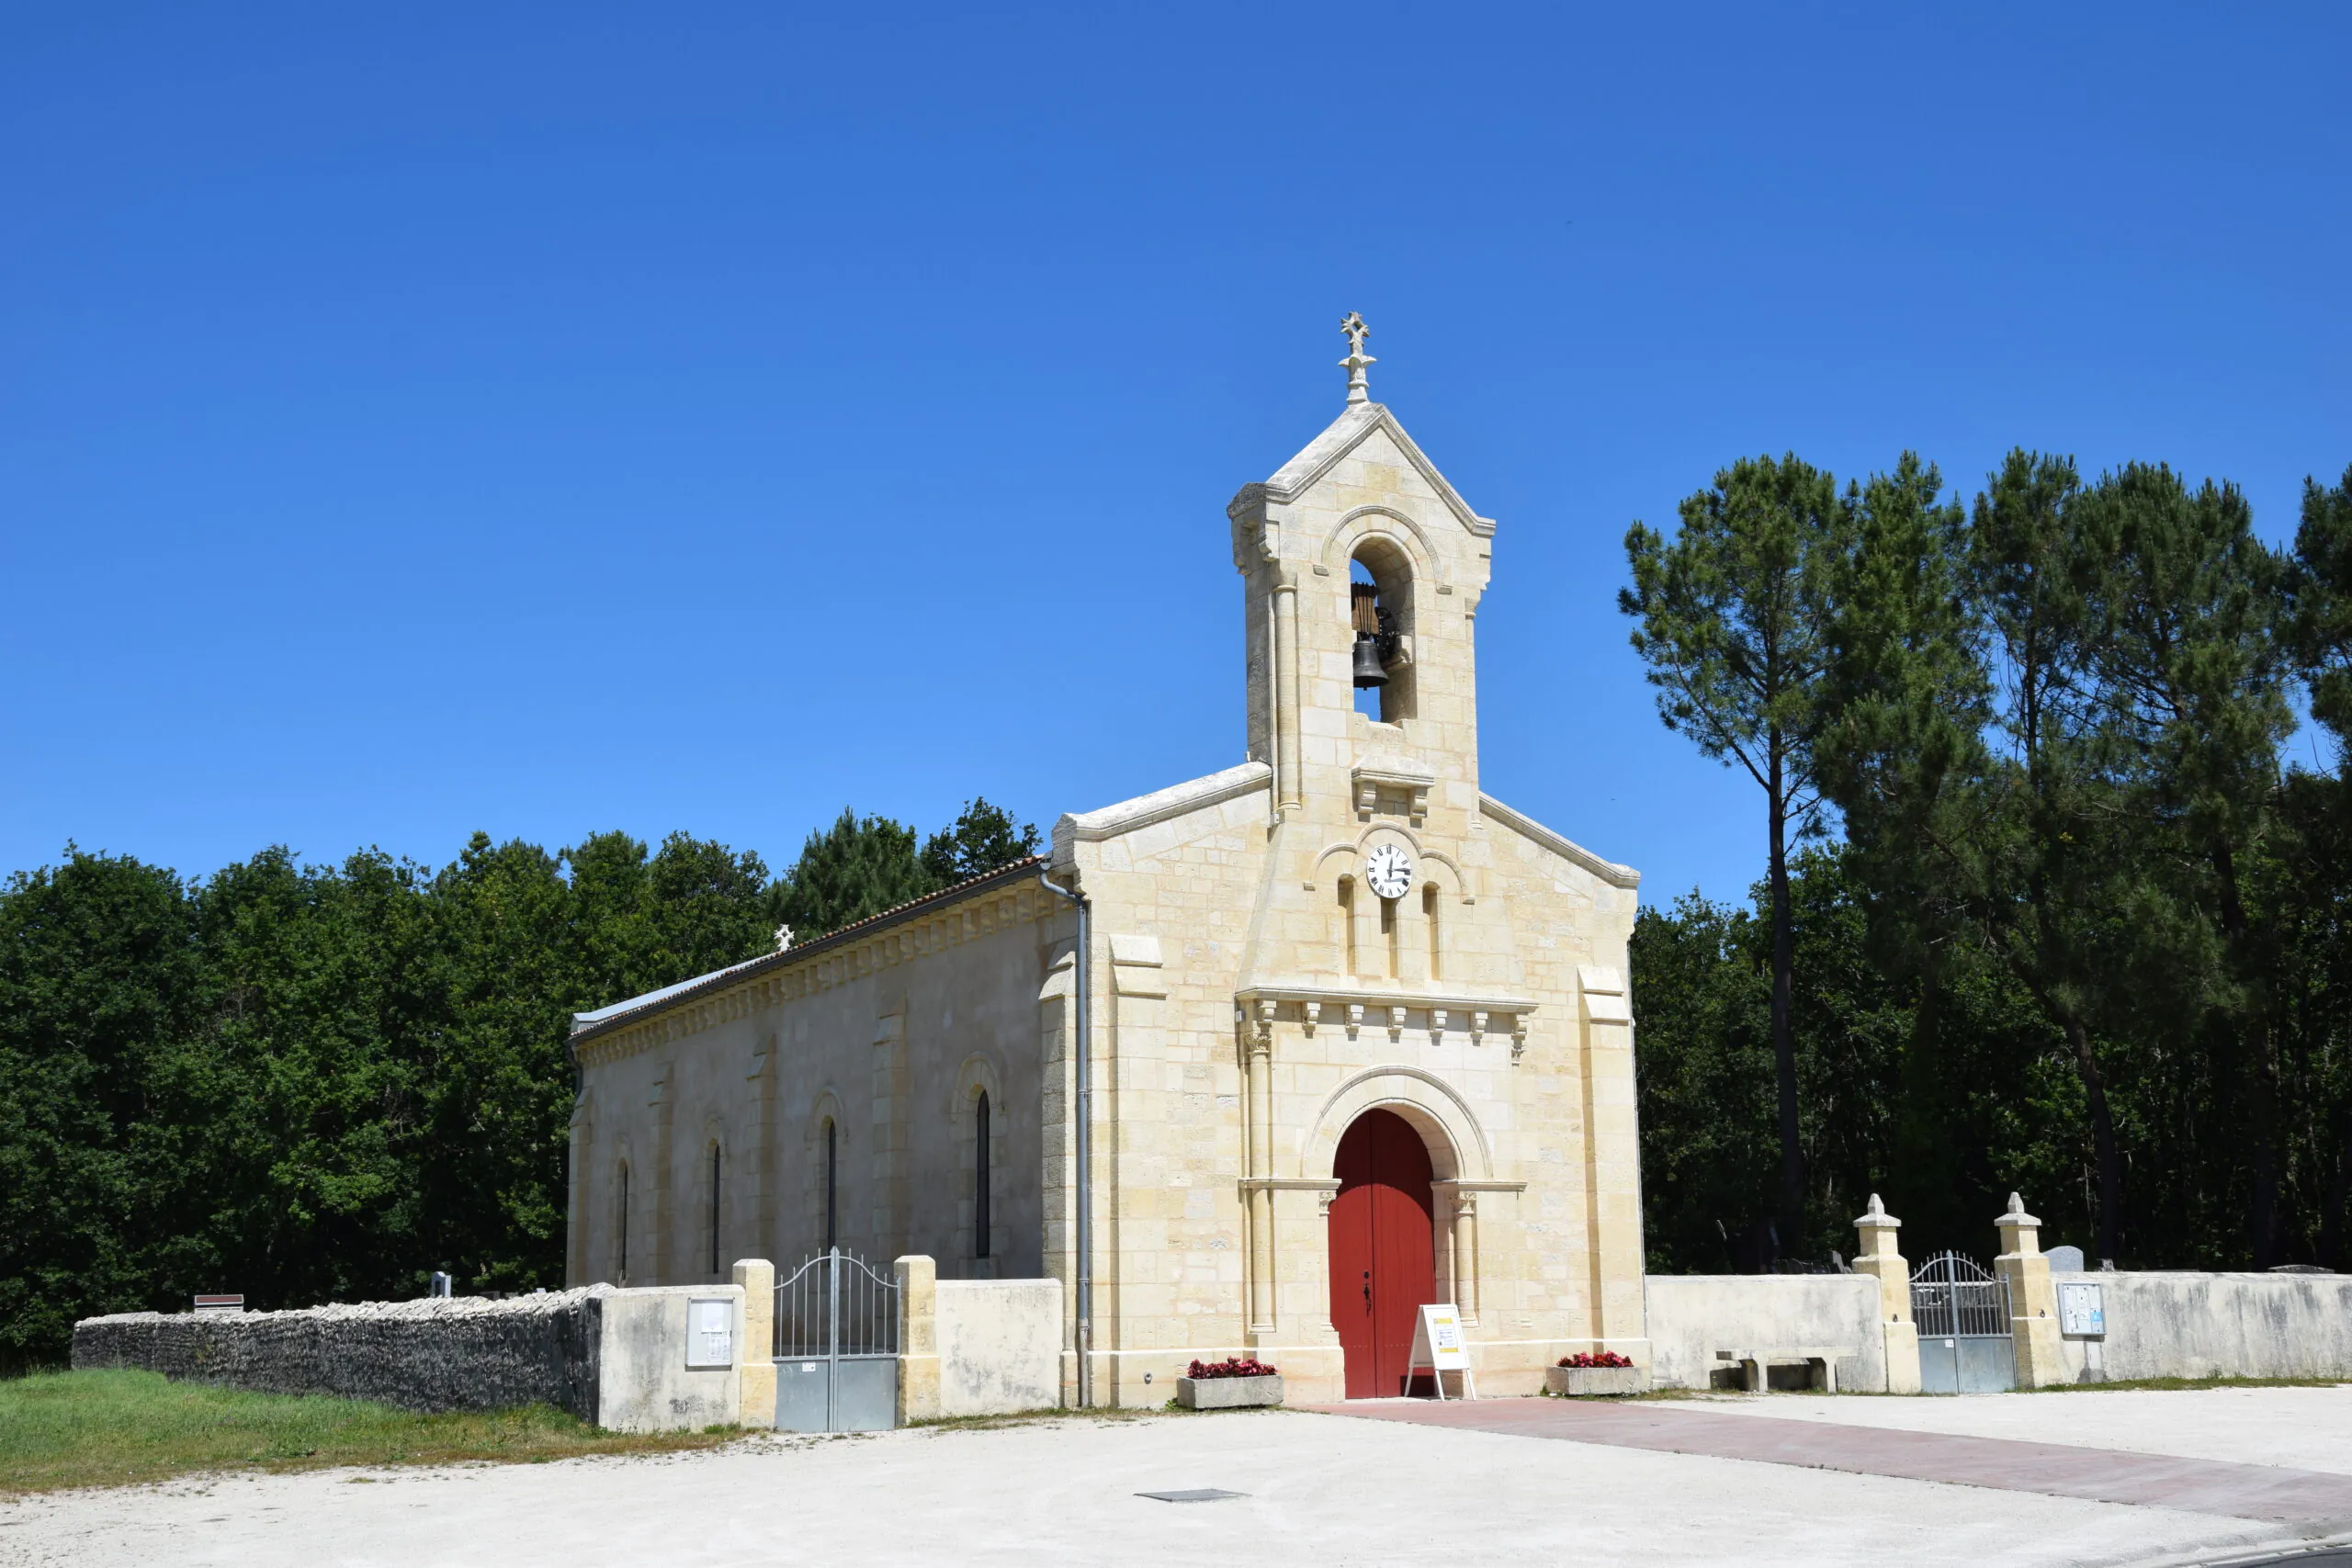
[567,317,1649,1405]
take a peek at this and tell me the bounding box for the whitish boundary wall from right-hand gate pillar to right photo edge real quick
[2051,1269,2352,1382]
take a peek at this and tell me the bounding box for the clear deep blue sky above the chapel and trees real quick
[0,5,2352,898]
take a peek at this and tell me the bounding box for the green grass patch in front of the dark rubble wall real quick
[0,1371,739,1497]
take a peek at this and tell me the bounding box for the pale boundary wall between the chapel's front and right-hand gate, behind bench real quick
[1642,1274,1886,1394]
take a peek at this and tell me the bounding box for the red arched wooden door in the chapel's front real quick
[1331,1110,1437,1399]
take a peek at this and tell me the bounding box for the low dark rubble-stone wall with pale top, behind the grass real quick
[73,1286,614,1422]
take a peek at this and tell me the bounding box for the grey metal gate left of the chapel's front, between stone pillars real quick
[776,1246,899,1432]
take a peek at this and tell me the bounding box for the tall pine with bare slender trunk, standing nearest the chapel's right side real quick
[1618,454,1851,1246]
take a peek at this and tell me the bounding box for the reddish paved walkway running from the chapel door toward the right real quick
[1310,1394,2352,1530]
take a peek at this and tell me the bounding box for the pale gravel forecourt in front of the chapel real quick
[0,1401,2314,1568]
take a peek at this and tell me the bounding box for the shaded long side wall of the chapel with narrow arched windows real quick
[570,886,1075,1283]
